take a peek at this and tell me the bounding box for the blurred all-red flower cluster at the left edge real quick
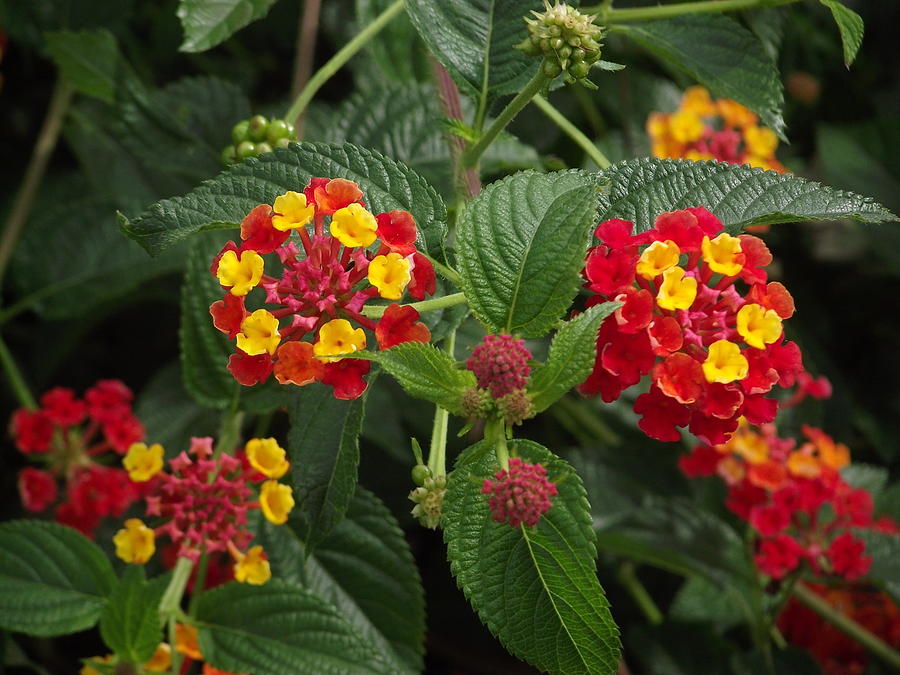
[10,380,144,536]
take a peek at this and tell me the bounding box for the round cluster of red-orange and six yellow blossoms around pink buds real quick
[210,178,436,399]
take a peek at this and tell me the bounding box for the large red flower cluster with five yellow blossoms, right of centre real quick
[579,207,821,444]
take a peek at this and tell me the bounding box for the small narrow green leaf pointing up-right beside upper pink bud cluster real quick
[528,302,620,412]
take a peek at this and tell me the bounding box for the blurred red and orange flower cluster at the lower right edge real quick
[679,424,900,581]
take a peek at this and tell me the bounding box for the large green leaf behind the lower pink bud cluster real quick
[444,440,619,673]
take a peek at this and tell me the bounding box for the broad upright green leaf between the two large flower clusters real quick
[456,171,597,337]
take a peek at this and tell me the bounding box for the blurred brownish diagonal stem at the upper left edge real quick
[0,78,72,280]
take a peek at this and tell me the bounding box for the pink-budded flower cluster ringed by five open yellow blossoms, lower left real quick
[114,438,294,584]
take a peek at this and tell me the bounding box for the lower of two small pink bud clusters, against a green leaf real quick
[481,457,557,527]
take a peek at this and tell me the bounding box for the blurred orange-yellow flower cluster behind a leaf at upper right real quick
[647,87,785,173]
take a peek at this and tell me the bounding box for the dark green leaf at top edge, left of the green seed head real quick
[406,0,544,100]
